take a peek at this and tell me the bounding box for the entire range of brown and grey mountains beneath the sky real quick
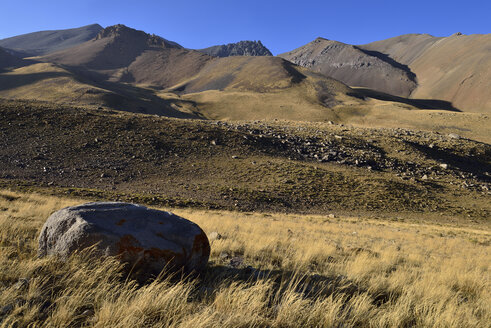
[0,24,491,140]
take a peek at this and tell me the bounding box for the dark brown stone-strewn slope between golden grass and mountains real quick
[0,100,491,220]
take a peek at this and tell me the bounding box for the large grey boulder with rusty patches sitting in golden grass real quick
[38,202,210,279]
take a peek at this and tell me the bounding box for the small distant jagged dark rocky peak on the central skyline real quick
[198,41,273,57]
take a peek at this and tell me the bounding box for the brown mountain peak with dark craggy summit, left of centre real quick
[40,25,212,88]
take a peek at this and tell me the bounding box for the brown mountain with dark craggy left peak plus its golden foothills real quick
[0,25,364,120]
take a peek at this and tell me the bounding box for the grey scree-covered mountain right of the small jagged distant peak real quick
[279,38,416,97]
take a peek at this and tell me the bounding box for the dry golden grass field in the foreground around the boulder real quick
[0,191,491,327]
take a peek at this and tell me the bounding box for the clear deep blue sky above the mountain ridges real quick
[0,0,491,54]
